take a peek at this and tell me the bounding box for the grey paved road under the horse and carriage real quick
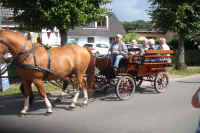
[0,75,200,133]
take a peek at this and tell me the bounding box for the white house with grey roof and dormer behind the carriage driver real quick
[68,12,125,46]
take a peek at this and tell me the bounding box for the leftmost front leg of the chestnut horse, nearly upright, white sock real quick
[21,80,32,114]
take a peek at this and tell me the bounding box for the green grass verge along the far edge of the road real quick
[0,67,200,96]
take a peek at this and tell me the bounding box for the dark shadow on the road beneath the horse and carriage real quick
[0,86,159,116]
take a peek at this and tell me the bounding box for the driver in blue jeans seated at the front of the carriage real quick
[109,34,128,70]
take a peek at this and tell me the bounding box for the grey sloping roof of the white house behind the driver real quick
[68,13,125,37]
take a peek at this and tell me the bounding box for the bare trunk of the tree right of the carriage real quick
[176,34,187,70]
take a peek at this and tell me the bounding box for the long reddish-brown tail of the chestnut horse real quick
[87,53,96,96]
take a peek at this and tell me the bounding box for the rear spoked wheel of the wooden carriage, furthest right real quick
[154,72,169,93]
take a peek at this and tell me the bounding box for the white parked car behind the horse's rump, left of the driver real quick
[83,43,109,56]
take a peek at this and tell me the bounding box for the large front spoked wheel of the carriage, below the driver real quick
[115,76,136,100]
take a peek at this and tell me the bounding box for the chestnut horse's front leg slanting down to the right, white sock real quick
[33,79,53,113]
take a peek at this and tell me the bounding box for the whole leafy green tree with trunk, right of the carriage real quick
[149,0,200,70]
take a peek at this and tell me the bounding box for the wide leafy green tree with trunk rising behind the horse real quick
[0,0,111,44]
